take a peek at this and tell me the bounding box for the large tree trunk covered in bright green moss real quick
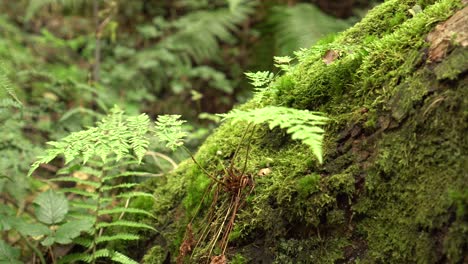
[144,0,468,263]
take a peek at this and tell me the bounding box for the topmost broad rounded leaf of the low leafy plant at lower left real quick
[34,190,68,225]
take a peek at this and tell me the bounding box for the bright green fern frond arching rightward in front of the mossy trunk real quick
[220,106,328,163]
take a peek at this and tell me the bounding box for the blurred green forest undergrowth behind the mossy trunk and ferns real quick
[0,0,378,260]
